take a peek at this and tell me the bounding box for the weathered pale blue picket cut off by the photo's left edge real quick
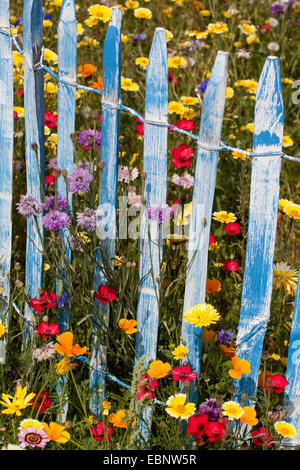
[0,0,14,364]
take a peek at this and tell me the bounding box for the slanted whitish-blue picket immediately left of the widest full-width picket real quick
[182,52,228,400]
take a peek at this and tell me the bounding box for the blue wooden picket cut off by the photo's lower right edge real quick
[283,266,300,447]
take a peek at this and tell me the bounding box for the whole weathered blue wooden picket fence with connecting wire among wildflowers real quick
[0,0,300,446]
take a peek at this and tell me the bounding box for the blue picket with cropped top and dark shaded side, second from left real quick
[23,0,44,343]
